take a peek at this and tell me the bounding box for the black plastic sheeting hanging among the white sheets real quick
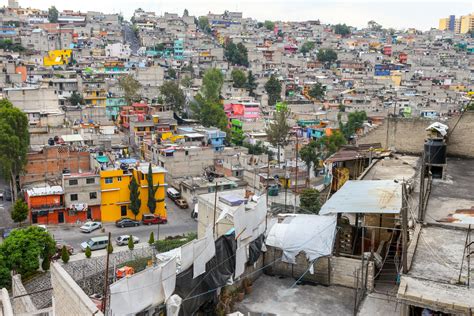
[175,234,237,315]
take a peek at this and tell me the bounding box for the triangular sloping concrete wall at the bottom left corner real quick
[51,262,103,316]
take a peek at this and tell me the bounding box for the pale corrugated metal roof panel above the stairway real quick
[319,180,402,215]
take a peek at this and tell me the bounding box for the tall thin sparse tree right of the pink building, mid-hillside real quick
[266,106,291,165]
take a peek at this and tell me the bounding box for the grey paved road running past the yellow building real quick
[48,198,197,253]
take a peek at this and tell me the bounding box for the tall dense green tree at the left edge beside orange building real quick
[0,99,30,200]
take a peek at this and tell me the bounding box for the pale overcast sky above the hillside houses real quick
[8,0,474,30]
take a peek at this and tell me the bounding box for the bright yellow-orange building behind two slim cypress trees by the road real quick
[100,164,167,222]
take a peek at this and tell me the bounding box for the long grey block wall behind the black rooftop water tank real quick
[357,111,474,158]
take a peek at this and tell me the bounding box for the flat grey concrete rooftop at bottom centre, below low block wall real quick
[235,275,354,315]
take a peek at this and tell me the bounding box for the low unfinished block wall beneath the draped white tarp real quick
[264,246,374,291]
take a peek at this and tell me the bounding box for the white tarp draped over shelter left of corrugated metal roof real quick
[266,215,337,263]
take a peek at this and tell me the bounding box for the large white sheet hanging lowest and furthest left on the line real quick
[110,266,164,315]
